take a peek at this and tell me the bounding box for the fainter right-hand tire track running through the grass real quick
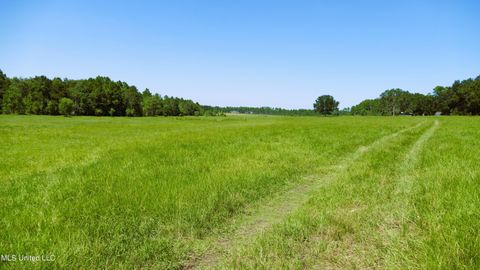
[306,120,439,269]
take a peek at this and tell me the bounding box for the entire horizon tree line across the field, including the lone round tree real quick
[0,70,480,116]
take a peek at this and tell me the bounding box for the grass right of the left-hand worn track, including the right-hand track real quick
[221,117,480,269]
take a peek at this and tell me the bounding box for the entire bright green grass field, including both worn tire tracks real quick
[0,115,480,269]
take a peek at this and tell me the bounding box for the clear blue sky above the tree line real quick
[0,0,480,108]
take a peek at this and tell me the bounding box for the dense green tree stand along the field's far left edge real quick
[0,70,203,116]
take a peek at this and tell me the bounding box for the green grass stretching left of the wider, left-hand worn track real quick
[0,116,422,269]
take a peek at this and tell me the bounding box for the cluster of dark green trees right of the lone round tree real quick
[350,76,480,115]
